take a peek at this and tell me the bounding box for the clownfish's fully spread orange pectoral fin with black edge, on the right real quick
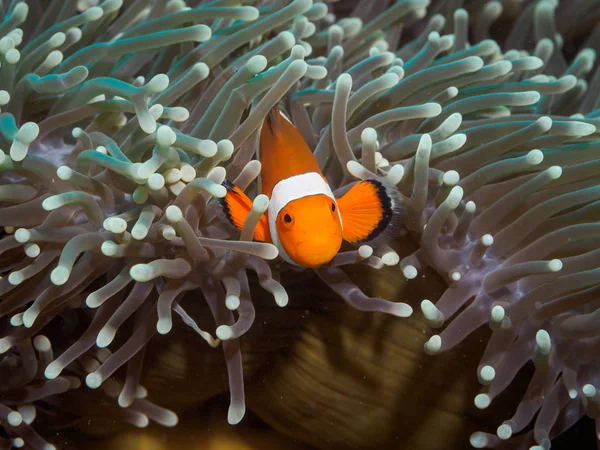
[337,180,399,243]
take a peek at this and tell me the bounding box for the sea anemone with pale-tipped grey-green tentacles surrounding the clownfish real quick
[0,0,600,450]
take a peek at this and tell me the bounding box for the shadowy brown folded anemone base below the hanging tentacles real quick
[55,236,526,450]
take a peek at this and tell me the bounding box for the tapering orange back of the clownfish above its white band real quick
[258,106,322,198]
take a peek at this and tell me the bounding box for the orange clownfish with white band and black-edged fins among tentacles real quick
[221,107,398,268]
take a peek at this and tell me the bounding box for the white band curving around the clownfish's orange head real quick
[267,172,344,265]
